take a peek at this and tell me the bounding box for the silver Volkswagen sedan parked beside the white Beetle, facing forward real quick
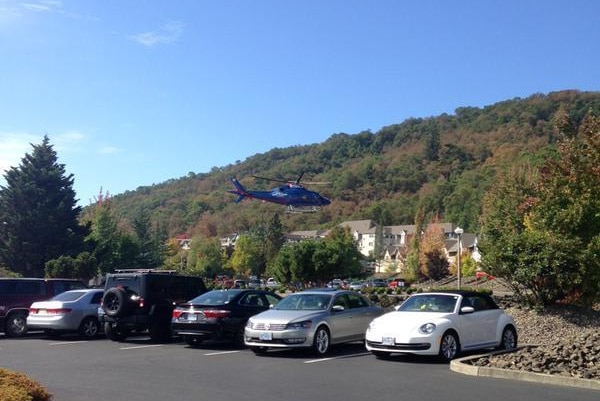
[244,290,383,356]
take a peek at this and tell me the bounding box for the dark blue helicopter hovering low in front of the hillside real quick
[229,173,331,213]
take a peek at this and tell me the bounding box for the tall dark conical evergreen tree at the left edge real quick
[0,136,87,277]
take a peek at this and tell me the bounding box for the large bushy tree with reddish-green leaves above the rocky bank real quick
[481,112,600,306]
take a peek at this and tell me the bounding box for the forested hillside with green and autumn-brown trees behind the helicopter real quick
[84,91,600,237]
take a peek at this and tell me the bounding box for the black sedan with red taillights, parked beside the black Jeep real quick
[171,289,281,347]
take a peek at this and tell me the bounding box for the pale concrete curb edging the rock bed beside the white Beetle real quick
[450,345,600,390]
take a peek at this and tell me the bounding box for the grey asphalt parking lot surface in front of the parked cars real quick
[0,333,598,401]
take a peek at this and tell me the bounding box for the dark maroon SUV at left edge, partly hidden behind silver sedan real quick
[0,278,87,337]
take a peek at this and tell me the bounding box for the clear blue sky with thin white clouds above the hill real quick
[0,0,600,206]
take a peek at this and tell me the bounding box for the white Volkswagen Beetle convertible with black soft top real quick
[365,291,517,361]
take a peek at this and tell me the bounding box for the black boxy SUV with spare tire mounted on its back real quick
[101,270,206,342]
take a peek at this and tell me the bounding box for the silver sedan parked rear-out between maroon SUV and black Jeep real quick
[27,289,104,339]
